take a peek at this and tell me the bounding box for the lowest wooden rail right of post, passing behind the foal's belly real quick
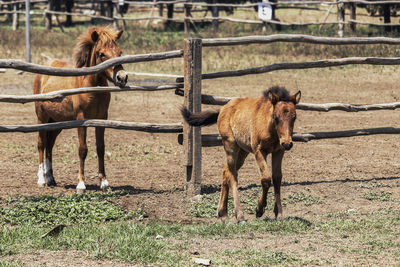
[178,127,400,147]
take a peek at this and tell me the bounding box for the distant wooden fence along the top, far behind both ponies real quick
[5,0,400,37]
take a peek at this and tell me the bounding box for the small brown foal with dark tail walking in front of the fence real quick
[181,86,301,222]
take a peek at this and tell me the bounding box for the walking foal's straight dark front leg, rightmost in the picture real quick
[272,150,285,219]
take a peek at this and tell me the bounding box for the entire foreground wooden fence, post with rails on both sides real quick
[0,35,400,196]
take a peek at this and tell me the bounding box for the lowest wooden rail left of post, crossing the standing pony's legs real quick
[0,119,183,133]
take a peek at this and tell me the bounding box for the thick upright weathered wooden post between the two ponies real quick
[183,38,202,197]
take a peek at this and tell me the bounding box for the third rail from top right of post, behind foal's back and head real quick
[175,88,400,112]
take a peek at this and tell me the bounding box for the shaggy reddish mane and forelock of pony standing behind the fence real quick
[74,26,117,68]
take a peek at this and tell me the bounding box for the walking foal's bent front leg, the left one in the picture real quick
[254,150,271,218]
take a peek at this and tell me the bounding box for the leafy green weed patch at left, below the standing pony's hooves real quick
[0,191,144,225]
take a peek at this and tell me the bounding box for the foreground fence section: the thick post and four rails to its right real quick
[175,35,400,195]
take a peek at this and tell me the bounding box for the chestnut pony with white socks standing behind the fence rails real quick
[33,27,128,193]
